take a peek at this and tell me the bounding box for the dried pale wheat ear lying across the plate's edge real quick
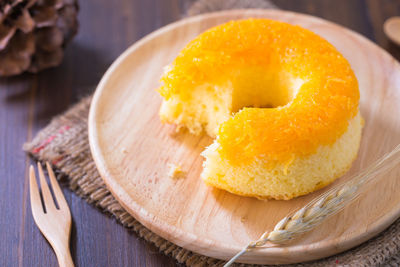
[224,145,400,267]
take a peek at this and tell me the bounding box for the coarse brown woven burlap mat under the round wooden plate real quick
[24,0,400,267]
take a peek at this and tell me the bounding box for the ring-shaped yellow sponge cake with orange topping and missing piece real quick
[158,19,363,199]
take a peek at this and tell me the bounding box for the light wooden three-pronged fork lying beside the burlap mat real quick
[29,162,74,267]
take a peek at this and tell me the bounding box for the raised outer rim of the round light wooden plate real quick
[88,9,400,263]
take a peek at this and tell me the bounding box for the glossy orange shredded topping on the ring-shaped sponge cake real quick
[159,19,359,168]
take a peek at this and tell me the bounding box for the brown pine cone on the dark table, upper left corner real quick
[0,0,78,76]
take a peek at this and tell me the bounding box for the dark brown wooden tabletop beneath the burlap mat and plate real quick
[0,0,400,266]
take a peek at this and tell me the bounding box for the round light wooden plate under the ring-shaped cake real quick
[89,10,400,263]
